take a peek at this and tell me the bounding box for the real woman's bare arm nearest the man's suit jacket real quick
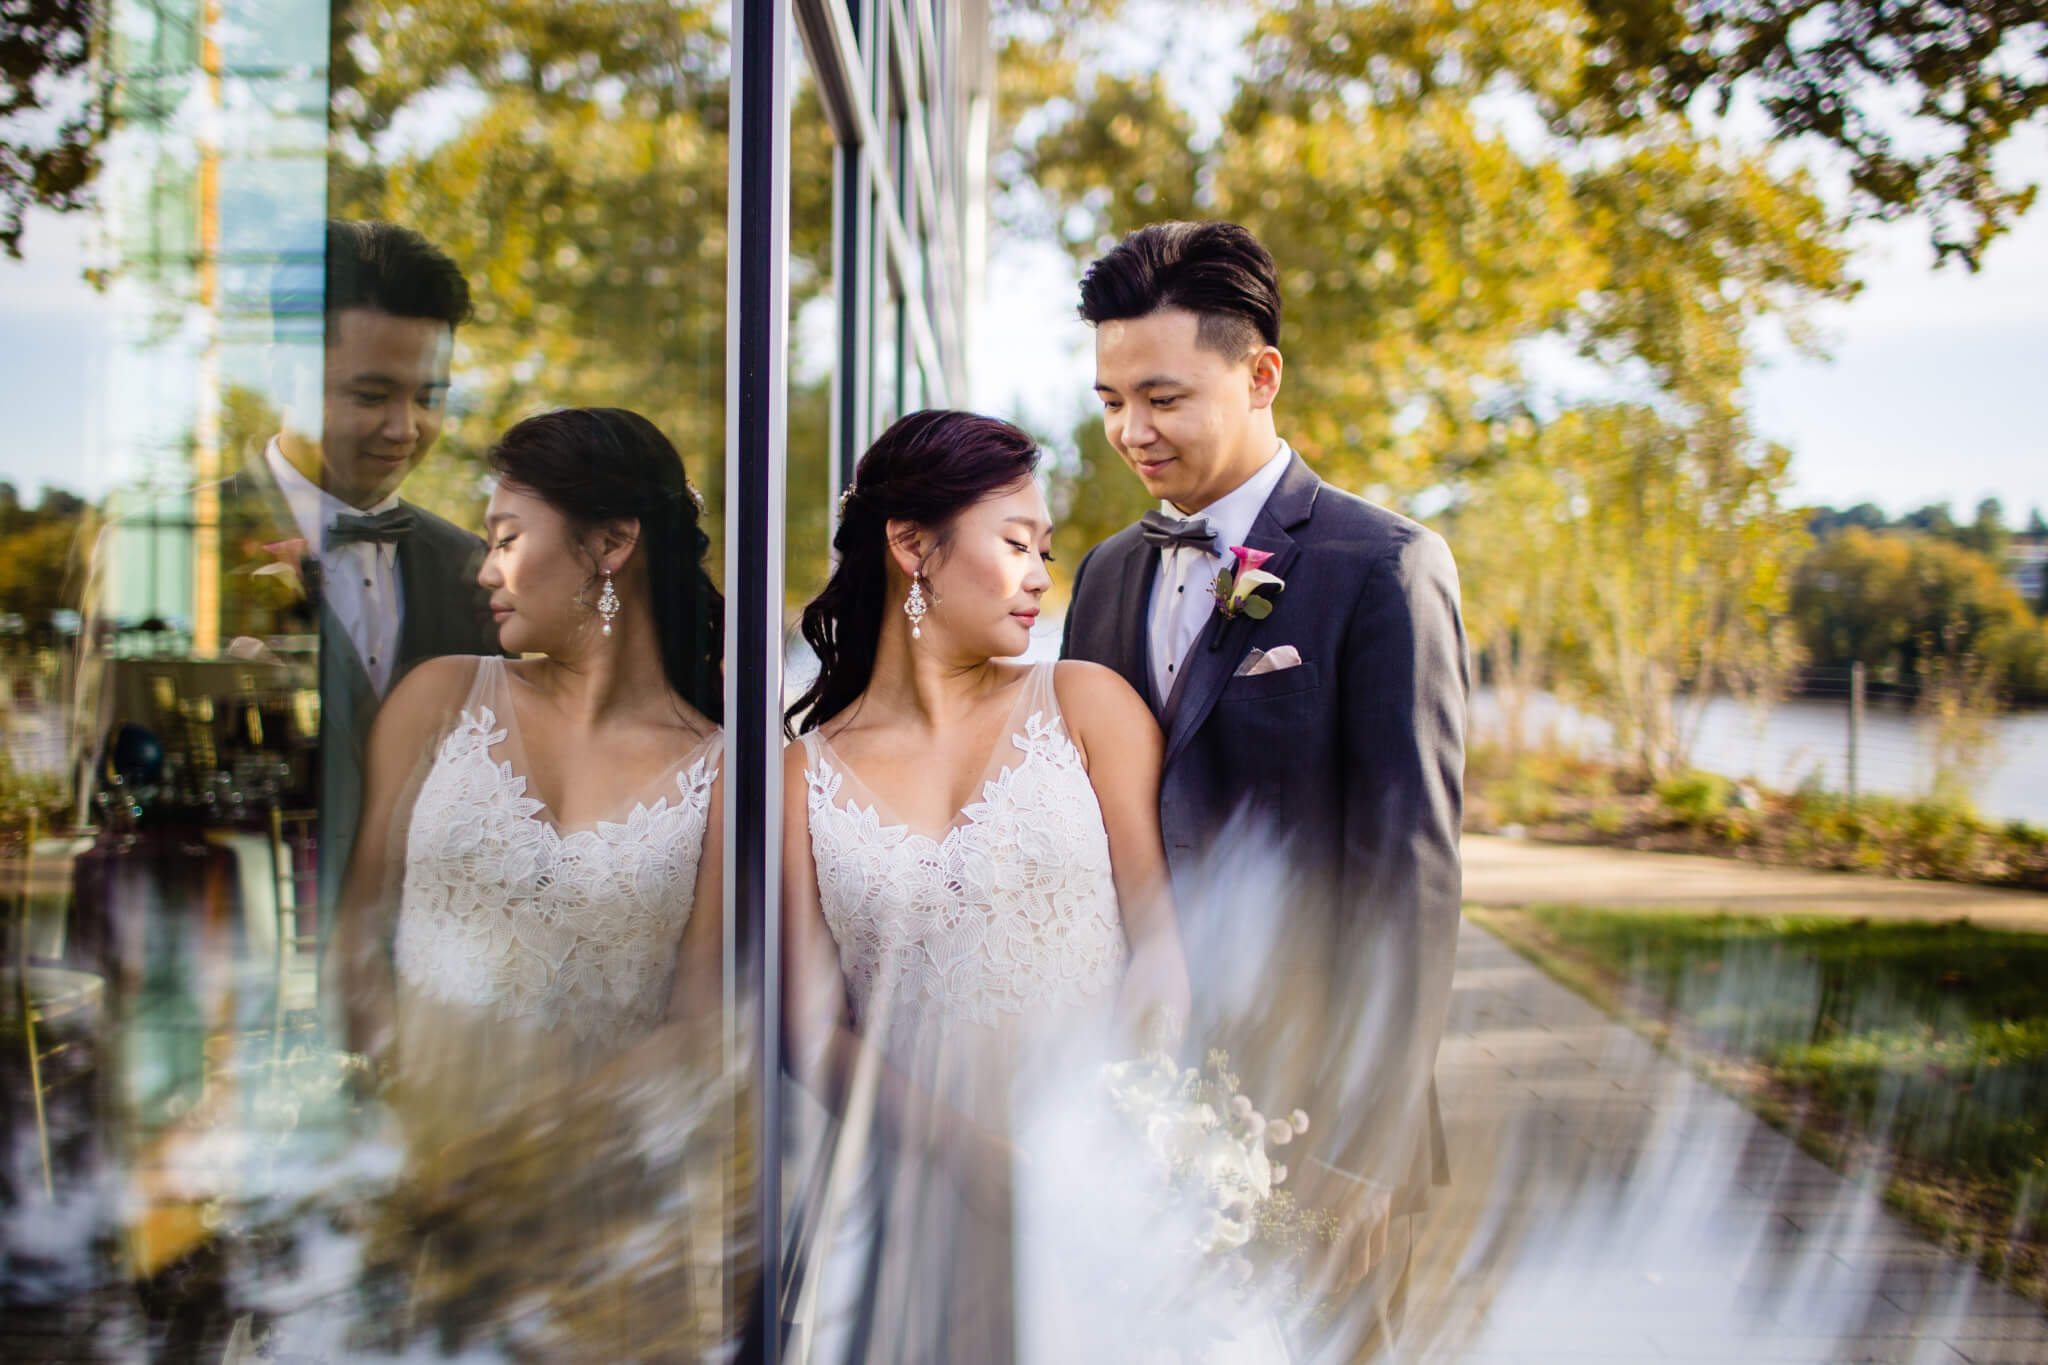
[1053,661,1190,1050]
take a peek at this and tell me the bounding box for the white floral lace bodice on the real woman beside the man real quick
[803,663,1128,1038]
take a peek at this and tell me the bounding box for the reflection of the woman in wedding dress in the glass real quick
[330,407,745,1359]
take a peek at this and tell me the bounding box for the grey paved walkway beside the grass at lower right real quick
[1401,925,2048,1365]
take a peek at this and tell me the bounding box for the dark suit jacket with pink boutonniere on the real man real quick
[1061,456,1468,1207]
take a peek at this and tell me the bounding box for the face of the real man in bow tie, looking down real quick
[1096,309,1278,514]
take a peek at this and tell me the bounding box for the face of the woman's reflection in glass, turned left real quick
[477,483,598,655]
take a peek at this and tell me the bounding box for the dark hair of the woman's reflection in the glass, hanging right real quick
[485,407,725,722]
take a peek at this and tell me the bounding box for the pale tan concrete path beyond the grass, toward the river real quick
[1464,835,2048,933]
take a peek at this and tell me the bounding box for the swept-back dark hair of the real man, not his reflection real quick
[1081,223,1280,360]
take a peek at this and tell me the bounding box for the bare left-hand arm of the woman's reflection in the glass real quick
[331,655,477,1056]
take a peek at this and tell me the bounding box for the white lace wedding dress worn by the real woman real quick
[799,663,1128,1365]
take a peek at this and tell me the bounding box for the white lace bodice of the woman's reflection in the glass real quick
[395,659,719,1046]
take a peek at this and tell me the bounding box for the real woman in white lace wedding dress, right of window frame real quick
[782,411,1188,1363]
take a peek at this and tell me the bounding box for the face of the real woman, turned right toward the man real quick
[922,479,1053,659]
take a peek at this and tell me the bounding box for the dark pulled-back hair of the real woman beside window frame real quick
[784,409,1038,731]
